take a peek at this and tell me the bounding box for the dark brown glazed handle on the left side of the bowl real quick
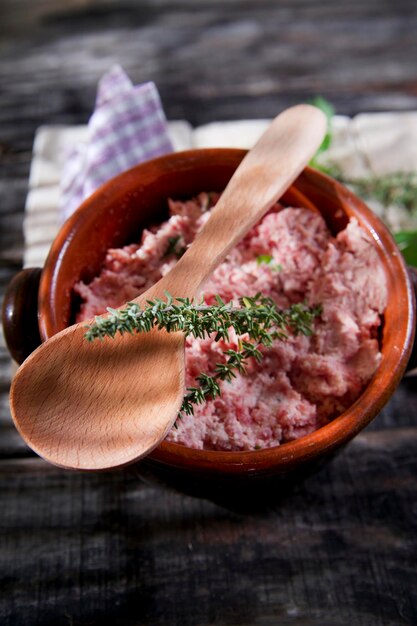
[2,267,42,364]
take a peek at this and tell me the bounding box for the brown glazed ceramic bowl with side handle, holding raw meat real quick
[4,149,415,498]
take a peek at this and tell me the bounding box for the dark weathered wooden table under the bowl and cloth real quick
[0,0,417,626]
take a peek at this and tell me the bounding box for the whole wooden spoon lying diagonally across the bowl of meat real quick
[10,105,326,470]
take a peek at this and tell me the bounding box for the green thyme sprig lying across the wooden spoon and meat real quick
[85,293,321,417]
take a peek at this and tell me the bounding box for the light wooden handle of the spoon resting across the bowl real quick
[154,104,327,298]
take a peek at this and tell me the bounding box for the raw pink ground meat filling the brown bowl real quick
[75,193,387,450]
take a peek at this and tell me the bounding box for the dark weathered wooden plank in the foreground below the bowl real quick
[0,429,417,626]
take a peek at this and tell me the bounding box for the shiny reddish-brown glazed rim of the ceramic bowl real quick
[39,148,415,474]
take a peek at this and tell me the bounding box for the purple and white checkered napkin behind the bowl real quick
[60,65,173,222]
